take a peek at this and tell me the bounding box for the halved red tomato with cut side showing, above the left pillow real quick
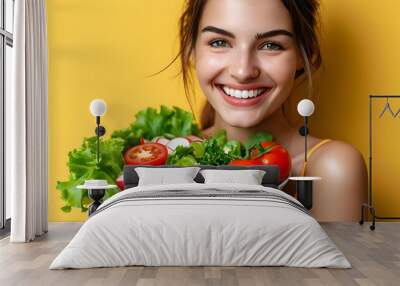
[124,143,168,166]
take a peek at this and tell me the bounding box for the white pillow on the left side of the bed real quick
[135,167,200,186]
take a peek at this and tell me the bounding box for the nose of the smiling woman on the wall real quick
[230,52,260,82]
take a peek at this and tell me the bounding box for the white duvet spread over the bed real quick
[50,183,351,269]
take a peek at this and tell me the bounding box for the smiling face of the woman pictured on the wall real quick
[193,0,301,127]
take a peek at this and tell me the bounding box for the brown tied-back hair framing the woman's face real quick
[153,0,322,129]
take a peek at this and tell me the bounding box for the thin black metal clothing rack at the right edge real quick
[359,95,400,230]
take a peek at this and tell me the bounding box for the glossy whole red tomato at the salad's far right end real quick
[250,141,292,182]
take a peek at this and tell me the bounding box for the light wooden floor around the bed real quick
[0,223,400,286]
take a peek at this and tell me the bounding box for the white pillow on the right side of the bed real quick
[200,169,265,185]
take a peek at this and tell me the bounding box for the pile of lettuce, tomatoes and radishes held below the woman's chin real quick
[56,106,291,212]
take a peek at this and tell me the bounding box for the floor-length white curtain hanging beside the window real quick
[6,0,48,242]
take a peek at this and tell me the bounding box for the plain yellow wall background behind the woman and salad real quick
[46,0,400,221]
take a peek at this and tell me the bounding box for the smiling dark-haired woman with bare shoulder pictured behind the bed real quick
[167,0,367,221]
